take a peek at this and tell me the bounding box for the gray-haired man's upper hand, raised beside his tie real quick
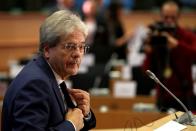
[68,89,90,116]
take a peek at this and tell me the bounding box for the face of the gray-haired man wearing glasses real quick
[44,30,85,79]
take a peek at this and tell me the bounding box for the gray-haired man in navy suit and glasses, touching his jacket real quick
[2,10,96,131]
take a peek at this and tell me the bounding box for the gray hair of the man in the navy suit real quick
[39,10,88,53]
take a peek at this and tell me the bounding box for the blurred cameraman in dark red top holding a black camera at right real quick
[143,1,196,111]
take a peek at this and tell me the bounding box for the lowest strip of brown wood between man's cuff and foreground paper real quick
[95,110,166,129]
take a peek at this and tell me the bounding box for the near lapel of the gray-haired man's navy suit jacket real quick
[36,56,65,115]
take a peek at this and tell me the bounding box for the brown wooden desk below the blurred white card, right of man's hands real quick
[91,96,166,129]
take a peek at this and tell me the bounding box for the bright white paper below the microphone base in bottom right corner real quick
[154,121,187,131]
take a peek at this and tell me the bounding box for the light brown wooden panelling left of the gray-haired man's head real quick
[0,13,45,73]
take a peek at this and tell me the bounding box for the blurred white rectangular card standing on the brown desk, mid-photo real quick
[114,81,136,98]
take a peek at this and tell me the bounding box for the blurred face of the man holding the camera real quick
[161,5,179,26]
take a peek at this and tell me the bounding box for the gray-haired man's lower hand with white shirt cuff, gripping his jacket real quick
[66,108,84,131]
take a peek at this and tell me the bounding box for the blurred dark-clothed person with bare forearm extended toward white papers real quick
[107,1,130,62]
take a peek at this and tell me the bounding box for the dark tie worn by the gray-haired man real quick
[60,82,76,108]
